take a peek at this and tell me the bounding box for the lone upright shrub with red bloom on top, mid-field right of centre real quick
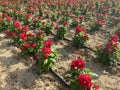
[72,26,89,48]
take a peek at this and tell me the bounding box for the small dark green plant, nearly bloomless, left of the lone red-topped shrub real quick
[56,26,67,39]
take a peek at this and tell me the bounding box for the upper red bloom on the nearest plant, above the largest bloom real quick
[71,58,85,69]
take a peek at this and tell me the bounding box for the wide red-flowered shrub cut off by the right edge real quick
[96,35,120,64]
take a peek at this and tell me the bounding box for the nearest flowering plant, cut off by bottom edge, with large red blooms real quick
[67,58,99,90]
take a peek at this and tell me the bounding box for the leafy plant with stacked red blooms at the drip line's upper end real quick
[37,40,58,72]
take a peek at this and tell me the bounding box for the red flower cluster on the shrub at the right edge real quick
[105,35,119,53]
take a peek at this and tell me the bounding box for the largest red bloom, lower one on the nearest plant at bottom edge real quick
[77,74,92,90]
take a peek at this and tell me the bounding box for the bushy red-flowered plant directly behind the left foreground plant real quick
[20,31,45,55]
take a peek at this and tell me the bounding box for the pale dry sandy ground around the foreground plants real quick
[0,29,120,90]
